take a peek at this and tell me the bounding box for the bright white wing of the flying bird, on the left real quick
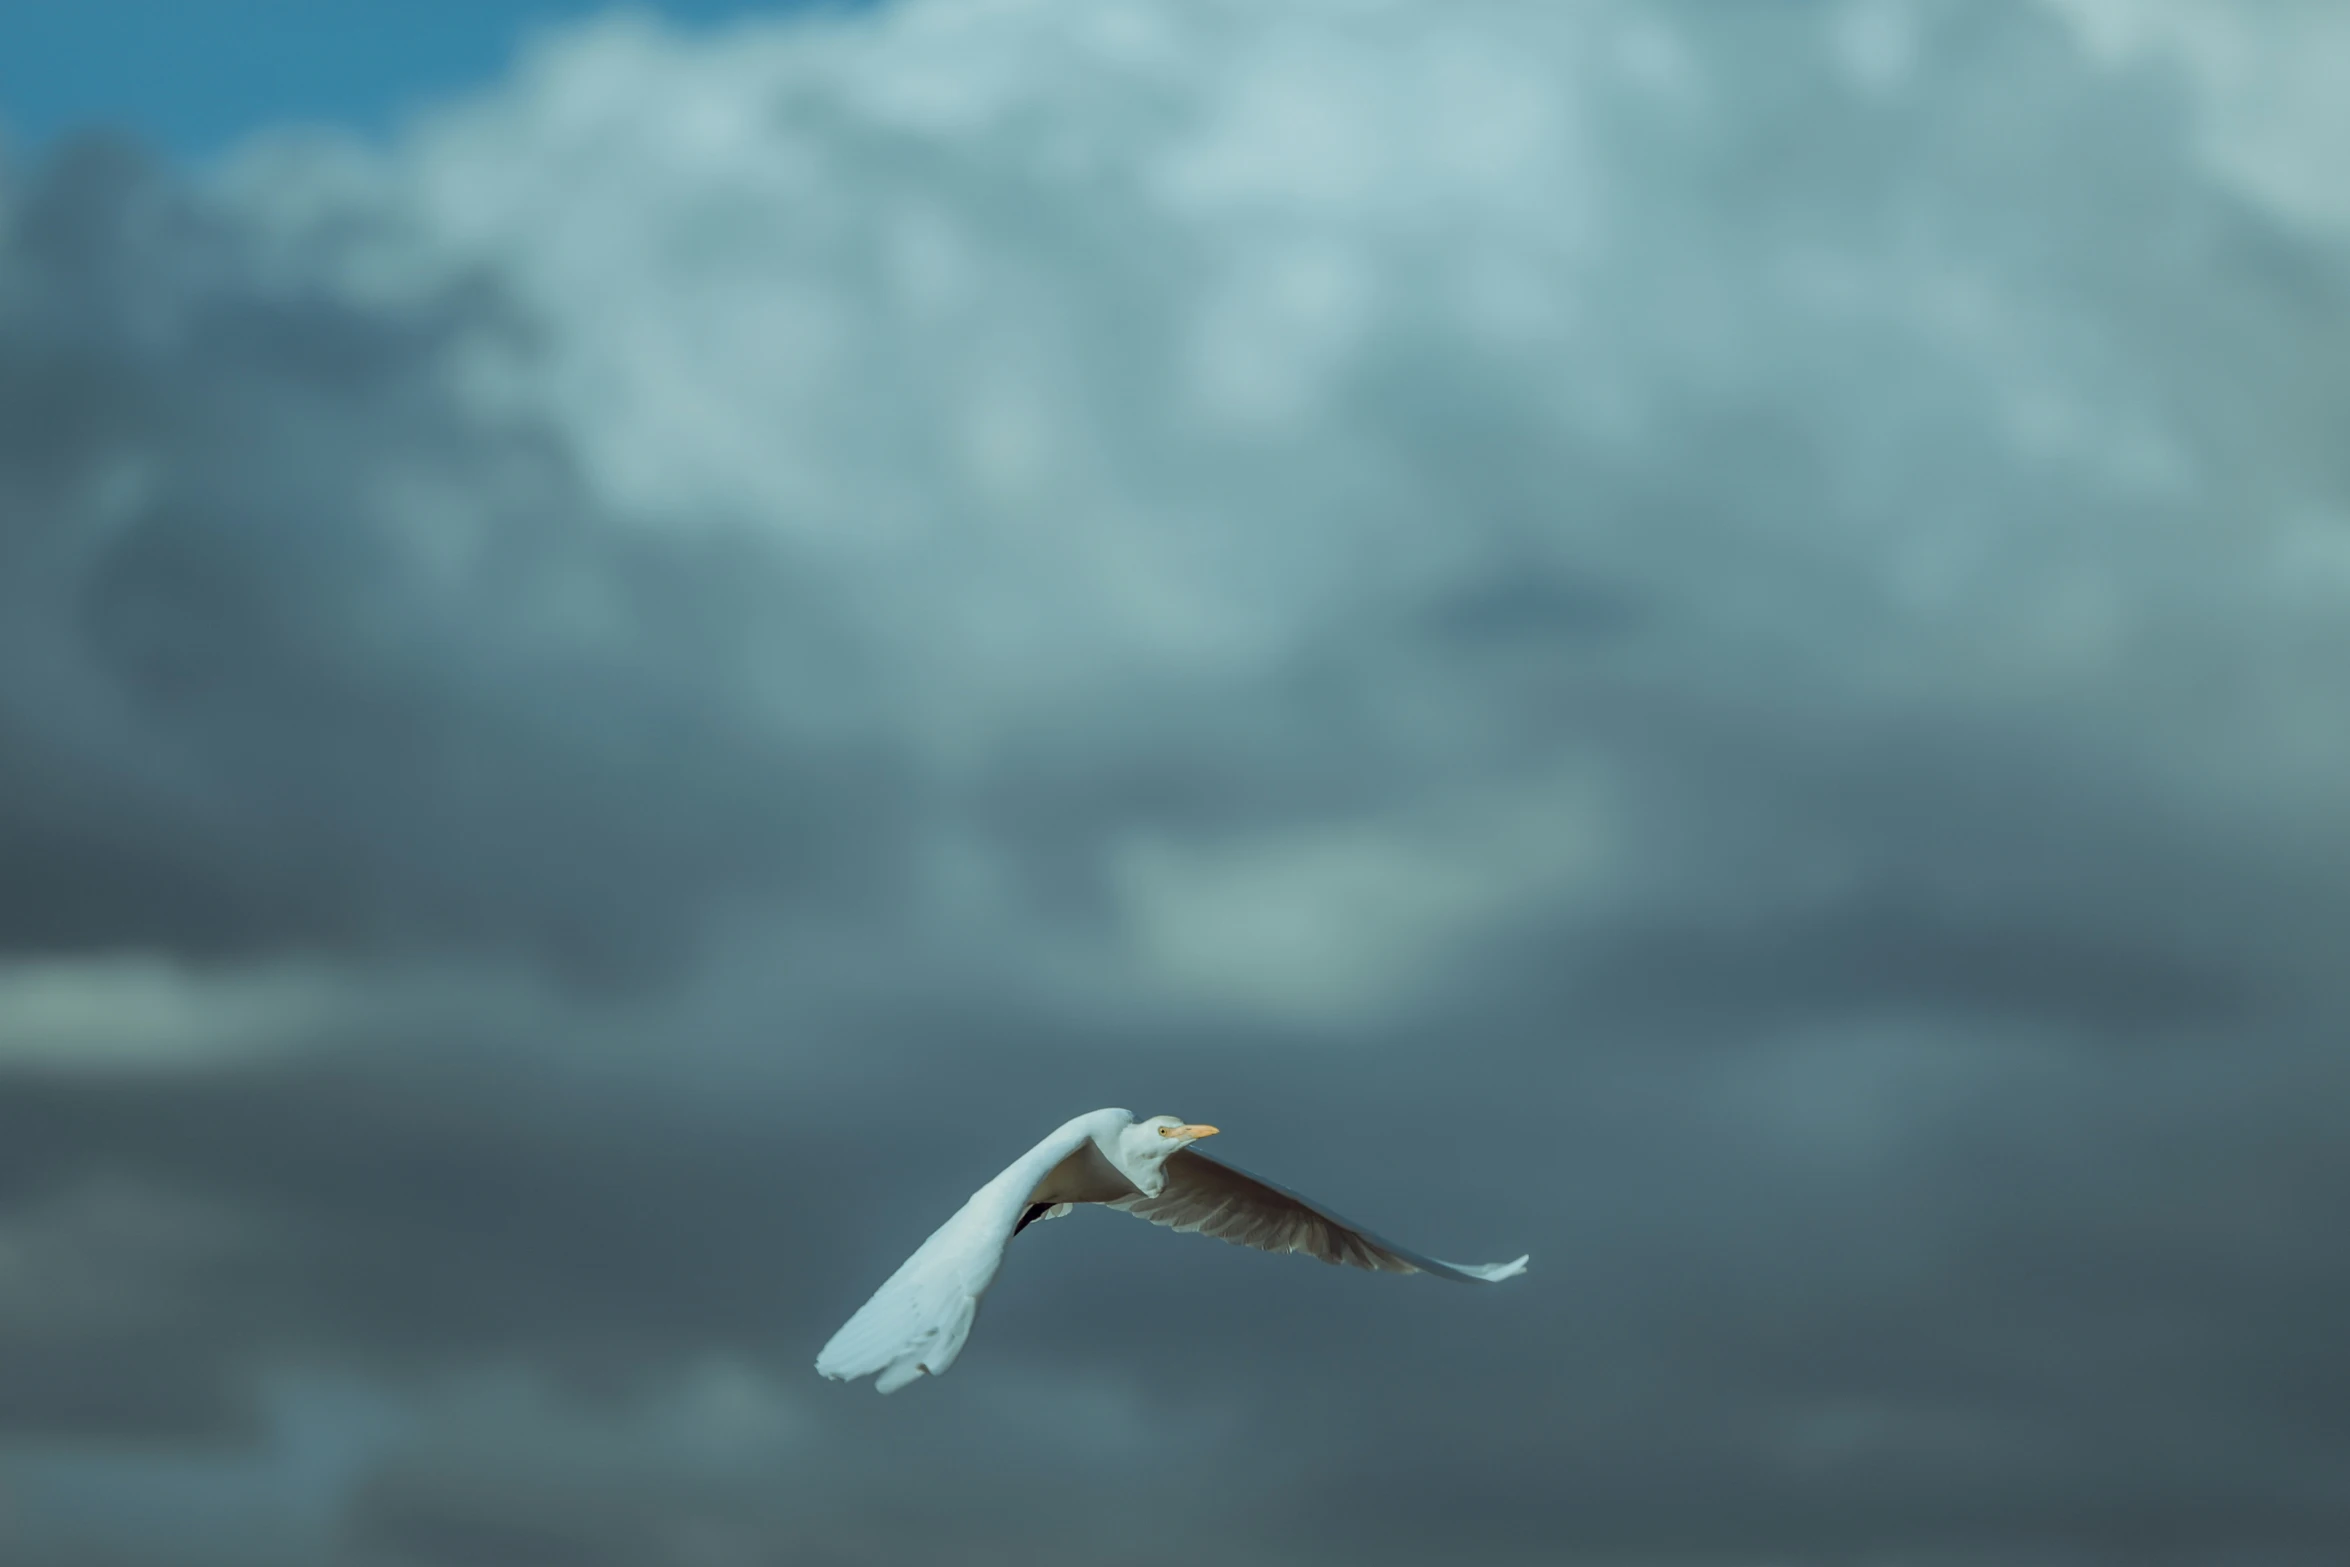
[815,1118,1109,1393]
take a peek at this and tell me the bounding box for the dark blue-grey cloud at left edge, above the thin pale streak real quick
[0,143,893,973]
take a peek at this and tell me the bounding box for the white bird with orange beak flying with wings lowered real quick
[815,1109,1525,1393]
